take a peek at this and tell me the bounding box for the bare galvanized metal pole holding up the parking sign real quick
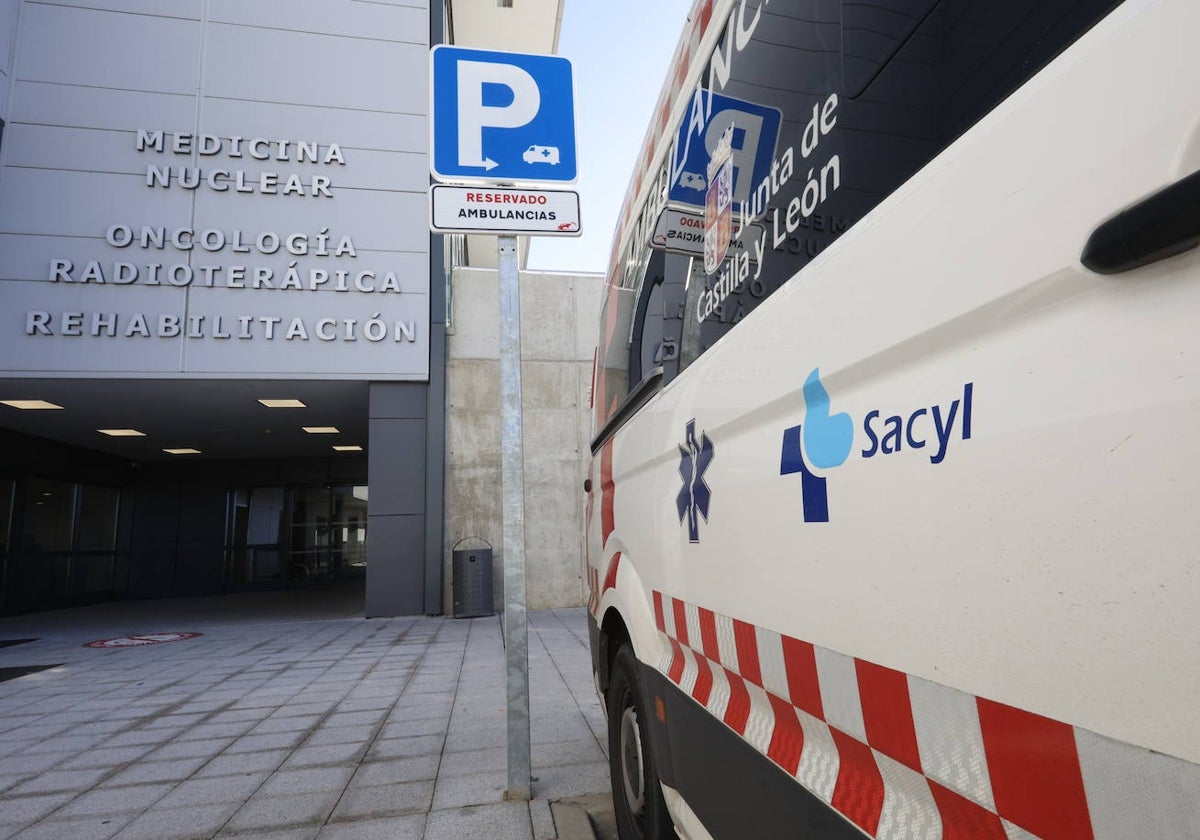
[497,231,532,800]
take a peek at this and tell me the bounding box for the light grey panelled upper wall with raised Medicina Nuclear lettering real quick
[0,0,430,380]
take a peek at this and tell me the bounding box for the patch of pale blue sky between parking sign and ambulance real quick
[529,0,692,272]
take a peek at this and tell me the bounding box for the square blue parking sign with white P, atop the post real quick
[430,46,578,184]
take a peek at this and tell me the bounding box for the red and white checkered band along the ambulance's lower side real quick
[653,592,1200,840]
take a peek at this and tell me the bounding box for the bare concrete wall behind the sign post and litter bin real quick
[445,262,604,613]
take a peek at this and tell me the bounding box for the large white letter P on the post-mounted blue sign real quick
[458,61,541,172]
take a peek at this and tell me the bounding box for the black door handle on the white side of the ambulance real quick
[1080,172,1200,274]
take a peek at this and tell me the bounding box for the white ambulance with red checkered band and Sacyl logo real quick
[587,0,1200,840]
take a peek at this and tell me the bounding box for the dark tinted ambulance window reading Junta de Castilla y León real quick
[671,0,1121,366]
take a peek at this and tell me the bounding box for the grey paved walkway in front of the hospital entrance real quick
[0,593,608,840]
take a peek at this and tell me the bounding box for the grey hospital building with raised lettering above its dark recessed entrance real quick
[0,0,595,616]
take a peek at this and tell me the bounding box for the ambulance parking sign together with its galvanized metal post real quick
[430,46,580,800]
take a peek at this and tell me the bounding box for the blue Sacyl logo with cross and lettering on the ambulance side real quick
[779,368,974,522]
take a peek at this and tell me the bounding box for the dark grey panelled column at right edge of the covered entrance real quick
[366,382,428,618]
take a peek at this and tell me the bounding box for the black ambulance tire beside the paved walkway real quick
[606,644,676,840]
